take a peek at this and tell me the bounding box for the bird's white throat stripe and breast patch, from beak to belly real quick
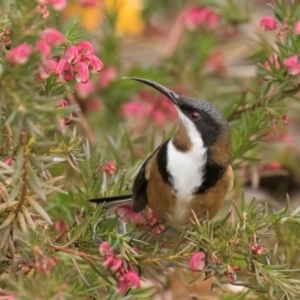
[167,111,207,219]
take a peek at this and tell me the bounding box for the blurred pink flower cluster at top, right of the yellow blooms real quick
[181,6,219,30]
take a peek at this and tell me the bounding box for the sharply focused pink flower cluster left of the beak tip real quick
[39,41,103,83]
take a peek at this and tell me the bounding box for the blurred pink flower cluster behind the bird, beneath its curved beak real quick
[121,91,177,125]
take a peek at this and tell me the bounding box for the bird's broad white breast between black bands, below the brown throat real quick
[167,143,207,202]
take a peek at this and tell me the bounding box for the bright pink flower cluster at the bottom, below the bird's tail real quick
[99,242,141,294]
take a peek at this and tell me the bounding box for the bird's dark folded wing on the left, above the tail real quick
[132,146,161,212]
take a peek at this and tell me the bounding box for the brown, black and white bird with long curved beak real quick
[89,77,234,228]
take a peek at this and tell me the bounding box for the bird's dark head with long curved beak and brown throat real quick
[126,77,231,162]
